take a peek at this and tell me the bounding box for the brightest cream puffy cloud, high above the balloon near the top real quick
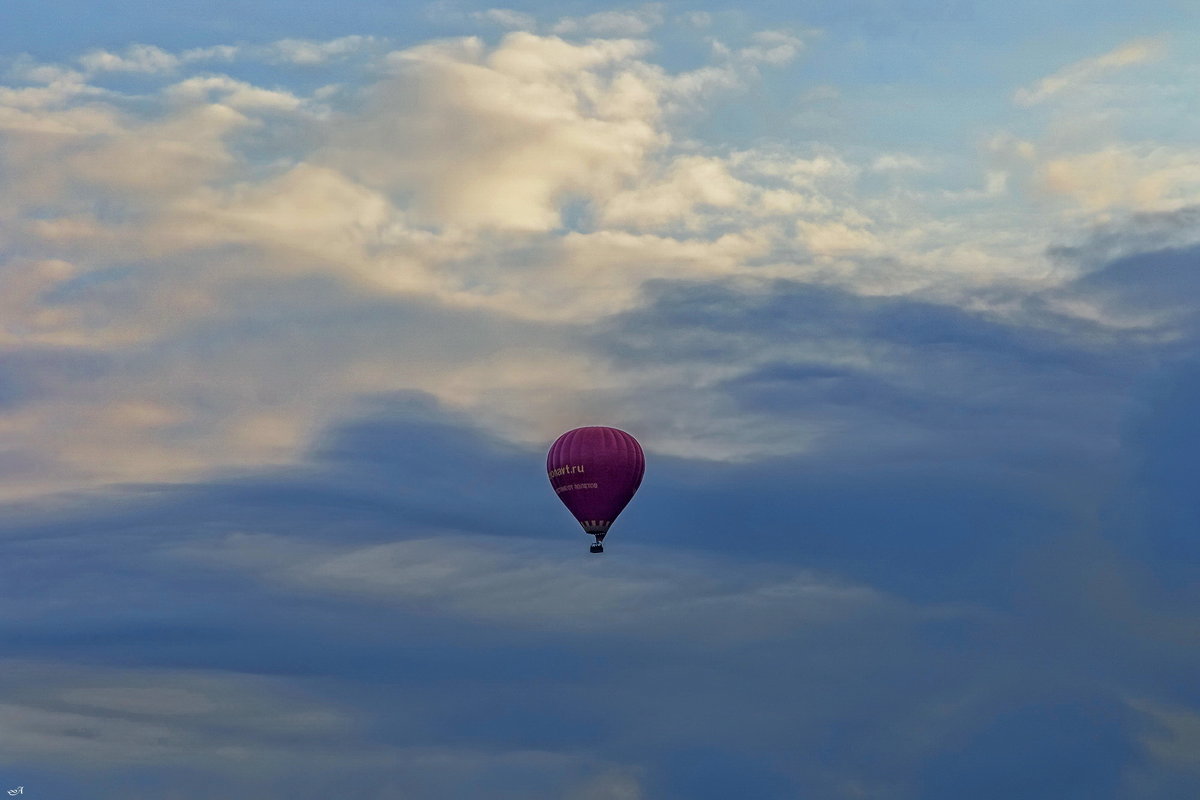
[330,34,666,233]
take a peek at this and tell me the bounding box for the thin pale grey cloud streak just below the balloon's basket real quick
[175,534,900,640]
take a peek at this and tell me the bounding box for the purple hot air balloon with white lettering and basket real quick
[546,426,646,553]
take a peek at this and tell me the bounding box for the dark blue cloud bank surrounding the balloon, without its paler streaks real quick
[7,214,1200,800]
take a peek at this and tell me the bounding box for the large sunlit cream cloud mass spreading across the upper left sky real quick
[0,31,1132,495]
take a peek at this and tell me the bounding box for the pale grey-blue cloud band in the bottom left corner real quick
[0,660,642,800]
